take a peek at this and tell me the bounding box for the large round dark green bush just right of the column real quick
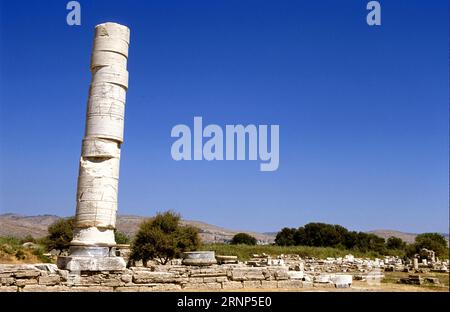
[130,211,200,266]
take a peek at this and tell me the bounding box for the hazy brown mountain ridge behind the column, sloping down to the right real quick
[0,213,275,244]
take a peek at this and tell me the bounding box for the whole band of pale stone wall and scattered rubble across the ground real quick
[0,250,449,292]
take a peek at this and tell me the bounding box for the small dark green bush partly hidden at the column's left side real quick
[44,217,75,251]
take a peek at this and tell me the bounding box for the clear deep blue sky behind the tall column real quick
[0,0,449,232]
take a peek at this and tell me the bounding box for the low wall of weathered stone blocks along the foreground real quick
[0,264,351,292]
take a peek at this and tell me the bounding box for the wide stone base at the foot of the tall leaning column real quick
[56,246,126,272]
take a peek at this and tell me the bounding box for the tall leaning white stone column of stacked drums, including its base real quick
[58,23,130,271]
